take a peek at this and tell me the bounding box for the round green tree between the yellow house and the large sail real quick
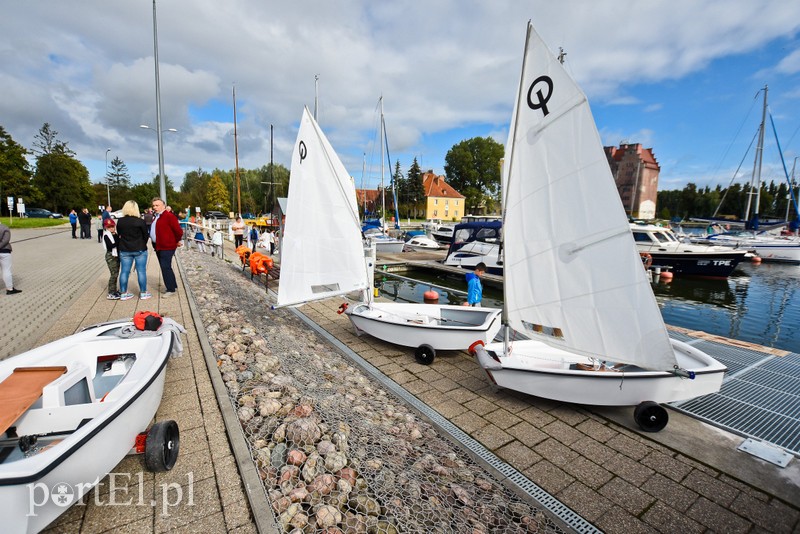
[444,137,504,215]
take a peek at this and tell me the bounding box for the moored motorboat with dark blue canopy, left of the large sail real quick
[443,220,503,276]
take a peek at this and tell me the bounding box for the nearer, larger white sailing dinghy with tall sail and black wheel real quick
[475,23,726,431]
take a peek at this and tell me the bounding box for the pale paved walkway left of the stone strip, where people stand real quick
[0,229,257,533]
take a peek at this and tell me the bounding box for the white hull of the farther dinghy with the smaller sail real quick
[347,302,501,350]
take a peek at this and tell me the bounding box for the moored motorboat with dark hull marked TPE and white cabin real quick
[630,223,747,279]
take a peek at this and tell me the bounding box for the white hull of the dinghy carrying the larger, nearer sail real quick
[475,340,727,406]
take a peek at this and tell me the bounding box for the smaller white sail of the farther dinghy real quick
[278,108,369,306]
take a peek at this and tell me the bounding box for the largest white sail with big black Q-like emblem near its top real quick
[503,24,676,370]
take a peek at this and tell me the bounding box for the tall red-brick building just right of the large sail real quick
[605,143,661,219]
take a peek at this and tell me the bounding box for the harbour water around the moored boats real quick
[375,263,800,353]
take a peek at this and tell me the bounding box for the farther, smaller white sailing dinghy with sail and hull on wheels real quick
[277,109,500,364]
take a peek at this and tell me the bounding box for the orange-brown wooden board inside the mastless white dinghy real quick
[0,365,67,433]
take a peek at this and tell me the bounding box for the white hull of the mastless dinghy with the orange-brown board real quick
[0,324,173,532]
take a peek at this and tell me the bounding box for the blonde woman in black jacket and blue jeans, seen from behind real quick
[117,200,152,300]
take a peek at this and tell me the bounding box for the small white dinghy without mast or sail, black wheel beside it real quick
[0,319,183,532]
